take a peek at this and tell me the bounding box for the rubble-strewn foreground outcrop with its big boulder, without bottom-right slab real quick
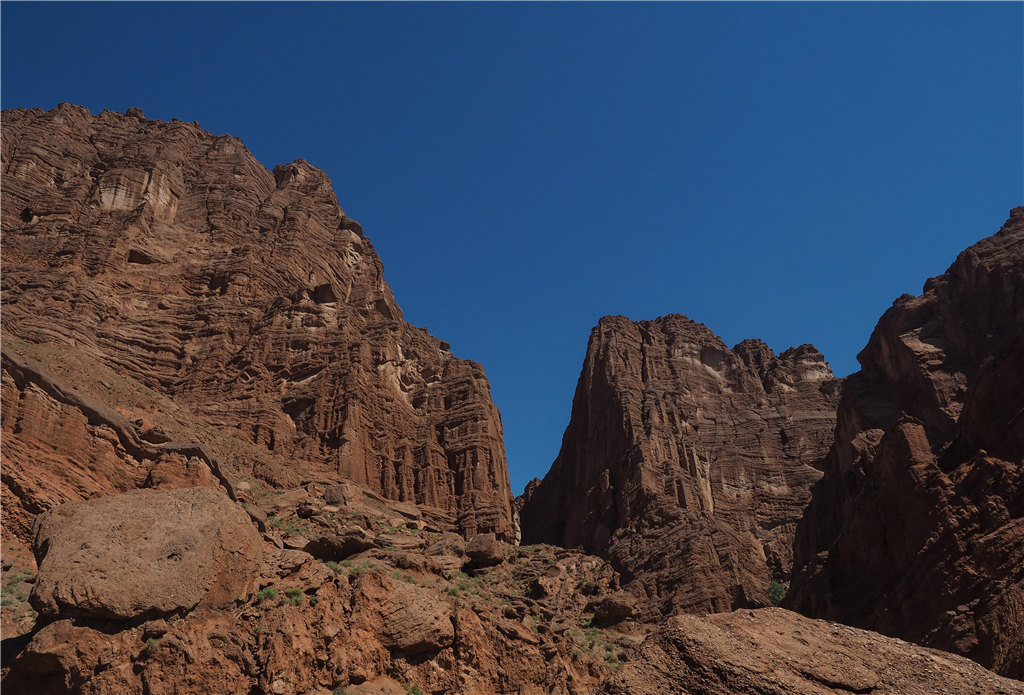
[2,485,643,695]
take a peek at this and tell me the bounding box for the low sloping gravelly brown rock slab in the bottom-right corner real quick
[595,608,1024,695]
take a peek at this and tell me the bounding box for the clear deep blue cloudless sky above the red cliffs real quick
[0,2,1024,492]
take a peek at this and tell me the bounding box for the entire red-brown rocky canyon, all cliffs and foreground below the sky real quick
[0,103,1024,695]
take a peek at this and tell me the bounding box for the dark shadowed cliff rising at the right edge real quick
[787,208,1024,679]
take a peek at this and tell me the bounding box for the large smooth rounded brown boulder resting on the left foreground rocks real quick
[30,487,262,620]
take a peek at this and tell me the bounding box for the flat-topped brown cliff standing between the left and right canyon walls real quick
[521,315,840,617]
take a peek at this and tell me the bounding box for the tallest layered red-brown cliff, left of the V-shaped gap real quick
[0,104,515,538]
